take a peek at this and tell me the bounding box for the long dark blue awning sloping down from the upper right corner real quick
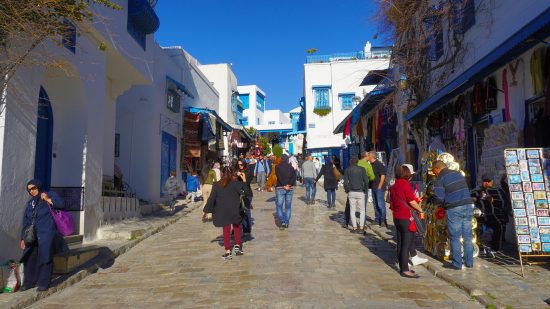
[405,8,550,121]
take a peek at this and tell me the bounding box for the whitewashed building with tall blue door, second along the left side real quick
[115,44,219,202]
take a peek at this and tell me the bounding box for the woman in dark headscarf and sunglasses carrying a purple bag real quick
[20,179,68,291]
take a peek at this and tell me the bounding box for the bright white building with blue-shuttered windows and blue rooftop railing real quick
[304,42,391,159]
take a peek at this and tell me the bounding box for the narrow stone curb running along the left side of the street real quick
[6,202,202,309]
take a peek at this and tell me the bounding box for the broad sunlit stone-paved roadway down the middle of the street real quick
[33,184,480,308]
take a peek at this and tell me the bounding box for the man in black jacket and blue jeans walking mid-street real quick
[275,155,296,230]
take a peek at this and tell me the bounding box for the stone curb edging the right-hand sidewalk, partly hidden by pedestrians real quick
[336,200,507,309]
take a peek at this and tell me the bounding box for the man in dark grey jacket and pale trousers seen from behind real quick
[344,157,369,233]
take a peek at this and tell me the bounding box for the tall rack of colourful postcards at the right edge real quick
[504,148,550,276]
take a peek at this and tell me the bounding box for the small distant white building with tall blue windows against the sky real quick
[237,85,266,127]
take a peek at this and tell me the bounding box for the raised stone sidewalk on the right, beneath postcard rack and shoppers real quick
[332,190,550,309]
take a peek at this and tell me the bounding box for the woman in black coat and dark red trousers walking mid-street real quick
[205,166,252,260]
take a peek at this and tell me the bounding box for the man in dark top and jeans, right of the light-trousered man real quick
[367,151,388,228]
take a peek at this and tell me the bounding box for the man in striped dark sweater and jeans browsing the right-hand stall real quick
[432,160,474,270]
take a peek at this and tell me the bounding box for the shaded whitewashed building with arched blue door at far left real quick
[0,0,159,260]
